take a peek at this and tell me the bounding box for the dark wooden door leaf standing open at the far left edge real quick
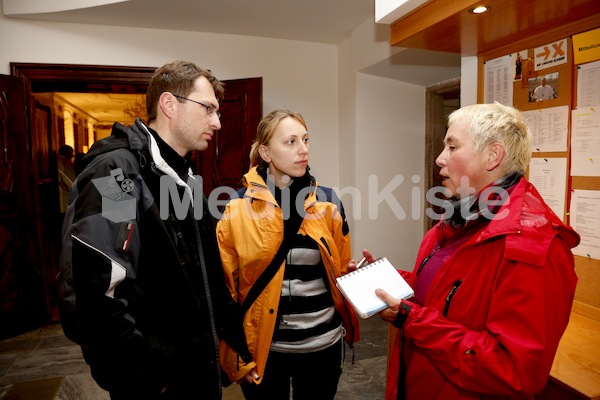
[0,75,46,338]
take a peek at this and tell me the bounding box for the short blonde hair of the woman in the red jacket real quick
[448,102,533,175]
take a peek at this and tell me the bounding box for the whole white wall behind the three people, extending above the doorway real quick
[0,10,432,268]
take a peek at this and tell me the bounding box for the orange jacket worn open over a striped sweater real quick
[217,168,360,382]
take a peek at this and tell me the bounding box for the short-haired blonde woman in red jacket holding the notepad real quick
[378,103,580,400]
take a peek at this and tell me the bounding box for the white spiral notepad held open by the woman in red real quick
[336,257,414,319]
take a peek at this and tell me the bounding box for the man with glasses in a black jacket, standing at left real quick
[58,61,258,400]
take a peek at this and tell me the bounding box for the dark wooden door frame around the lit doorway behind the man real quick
[10,62,156,328]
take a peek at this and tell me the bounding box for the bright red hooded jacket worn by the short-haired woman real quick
[386,178,579,400]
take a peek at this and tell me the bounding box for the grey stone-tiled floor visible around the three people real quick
[0,316,387,400]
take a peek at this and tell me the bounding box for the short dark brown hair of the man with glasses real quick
[146,61,224,123]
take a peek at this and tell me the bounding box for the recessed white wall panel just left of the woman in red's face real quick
[354,74,425,270]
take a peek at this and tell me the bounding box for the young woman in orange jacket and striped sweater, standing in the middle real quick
[217,110,359,400]
